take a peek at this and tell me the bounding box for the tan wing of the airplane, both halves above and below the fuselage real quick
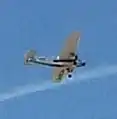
[53,32,80,81]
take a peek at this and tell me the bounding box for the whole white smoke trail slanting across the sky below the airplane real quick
[0,65,117,102]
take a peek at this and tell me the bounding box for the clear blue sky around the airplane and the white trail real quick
[0,0,117,119]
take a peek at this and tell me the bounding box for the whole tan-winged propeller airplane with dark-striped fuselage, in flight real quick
[24,32,86,82]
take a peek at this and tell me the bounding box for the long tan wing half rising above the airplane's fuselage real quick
[59,32,80,59]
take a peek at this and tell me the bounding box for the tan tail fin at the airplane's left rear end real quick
[24,49,36,64]
